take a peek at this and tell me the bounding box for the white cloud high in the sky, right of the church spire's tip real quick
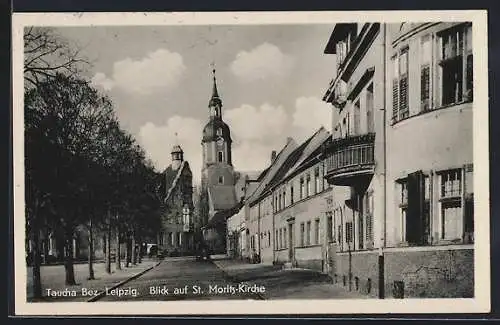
[231,43,293,81]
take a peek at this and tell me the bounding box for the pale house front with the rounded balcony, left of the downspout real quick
[323,23,388,294]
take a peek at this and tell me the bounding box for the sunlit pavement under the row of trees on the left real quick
[26,258,159,302]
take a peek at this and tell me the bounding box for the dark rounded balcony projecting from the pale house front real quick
[325,133,375,186]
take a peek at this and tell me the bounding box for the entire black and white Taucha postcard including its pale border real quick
[13,11,490,315]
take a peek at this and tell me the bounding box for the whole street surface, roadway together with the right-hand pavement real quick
[99,257,367,301]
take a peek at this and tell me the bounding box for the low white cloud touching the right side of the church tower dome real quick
[224,103,288,141]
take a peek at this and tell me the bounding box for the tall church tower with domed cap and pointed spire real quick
[201,69,234,187]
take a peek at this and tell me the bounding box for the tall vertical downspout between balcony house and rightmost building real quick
[378,23,387,299]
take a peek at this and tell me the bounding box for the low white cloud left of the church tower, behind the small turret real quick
[139,115,203,185]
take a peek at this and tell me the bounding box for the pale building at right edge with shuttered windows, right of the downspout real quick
[384,22,474,297]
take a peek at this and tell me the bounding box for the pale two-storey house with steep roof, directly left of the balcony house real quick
[268,127,331,271]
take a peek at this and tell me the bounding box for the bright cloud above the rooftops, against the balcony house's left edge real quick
[292,97,332,141]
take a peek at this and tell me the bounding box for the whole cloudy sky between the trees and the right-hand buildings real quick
[58,25,335,182]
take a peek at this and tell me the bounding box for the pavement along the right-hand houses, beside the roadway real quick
[212,257,369,299]
